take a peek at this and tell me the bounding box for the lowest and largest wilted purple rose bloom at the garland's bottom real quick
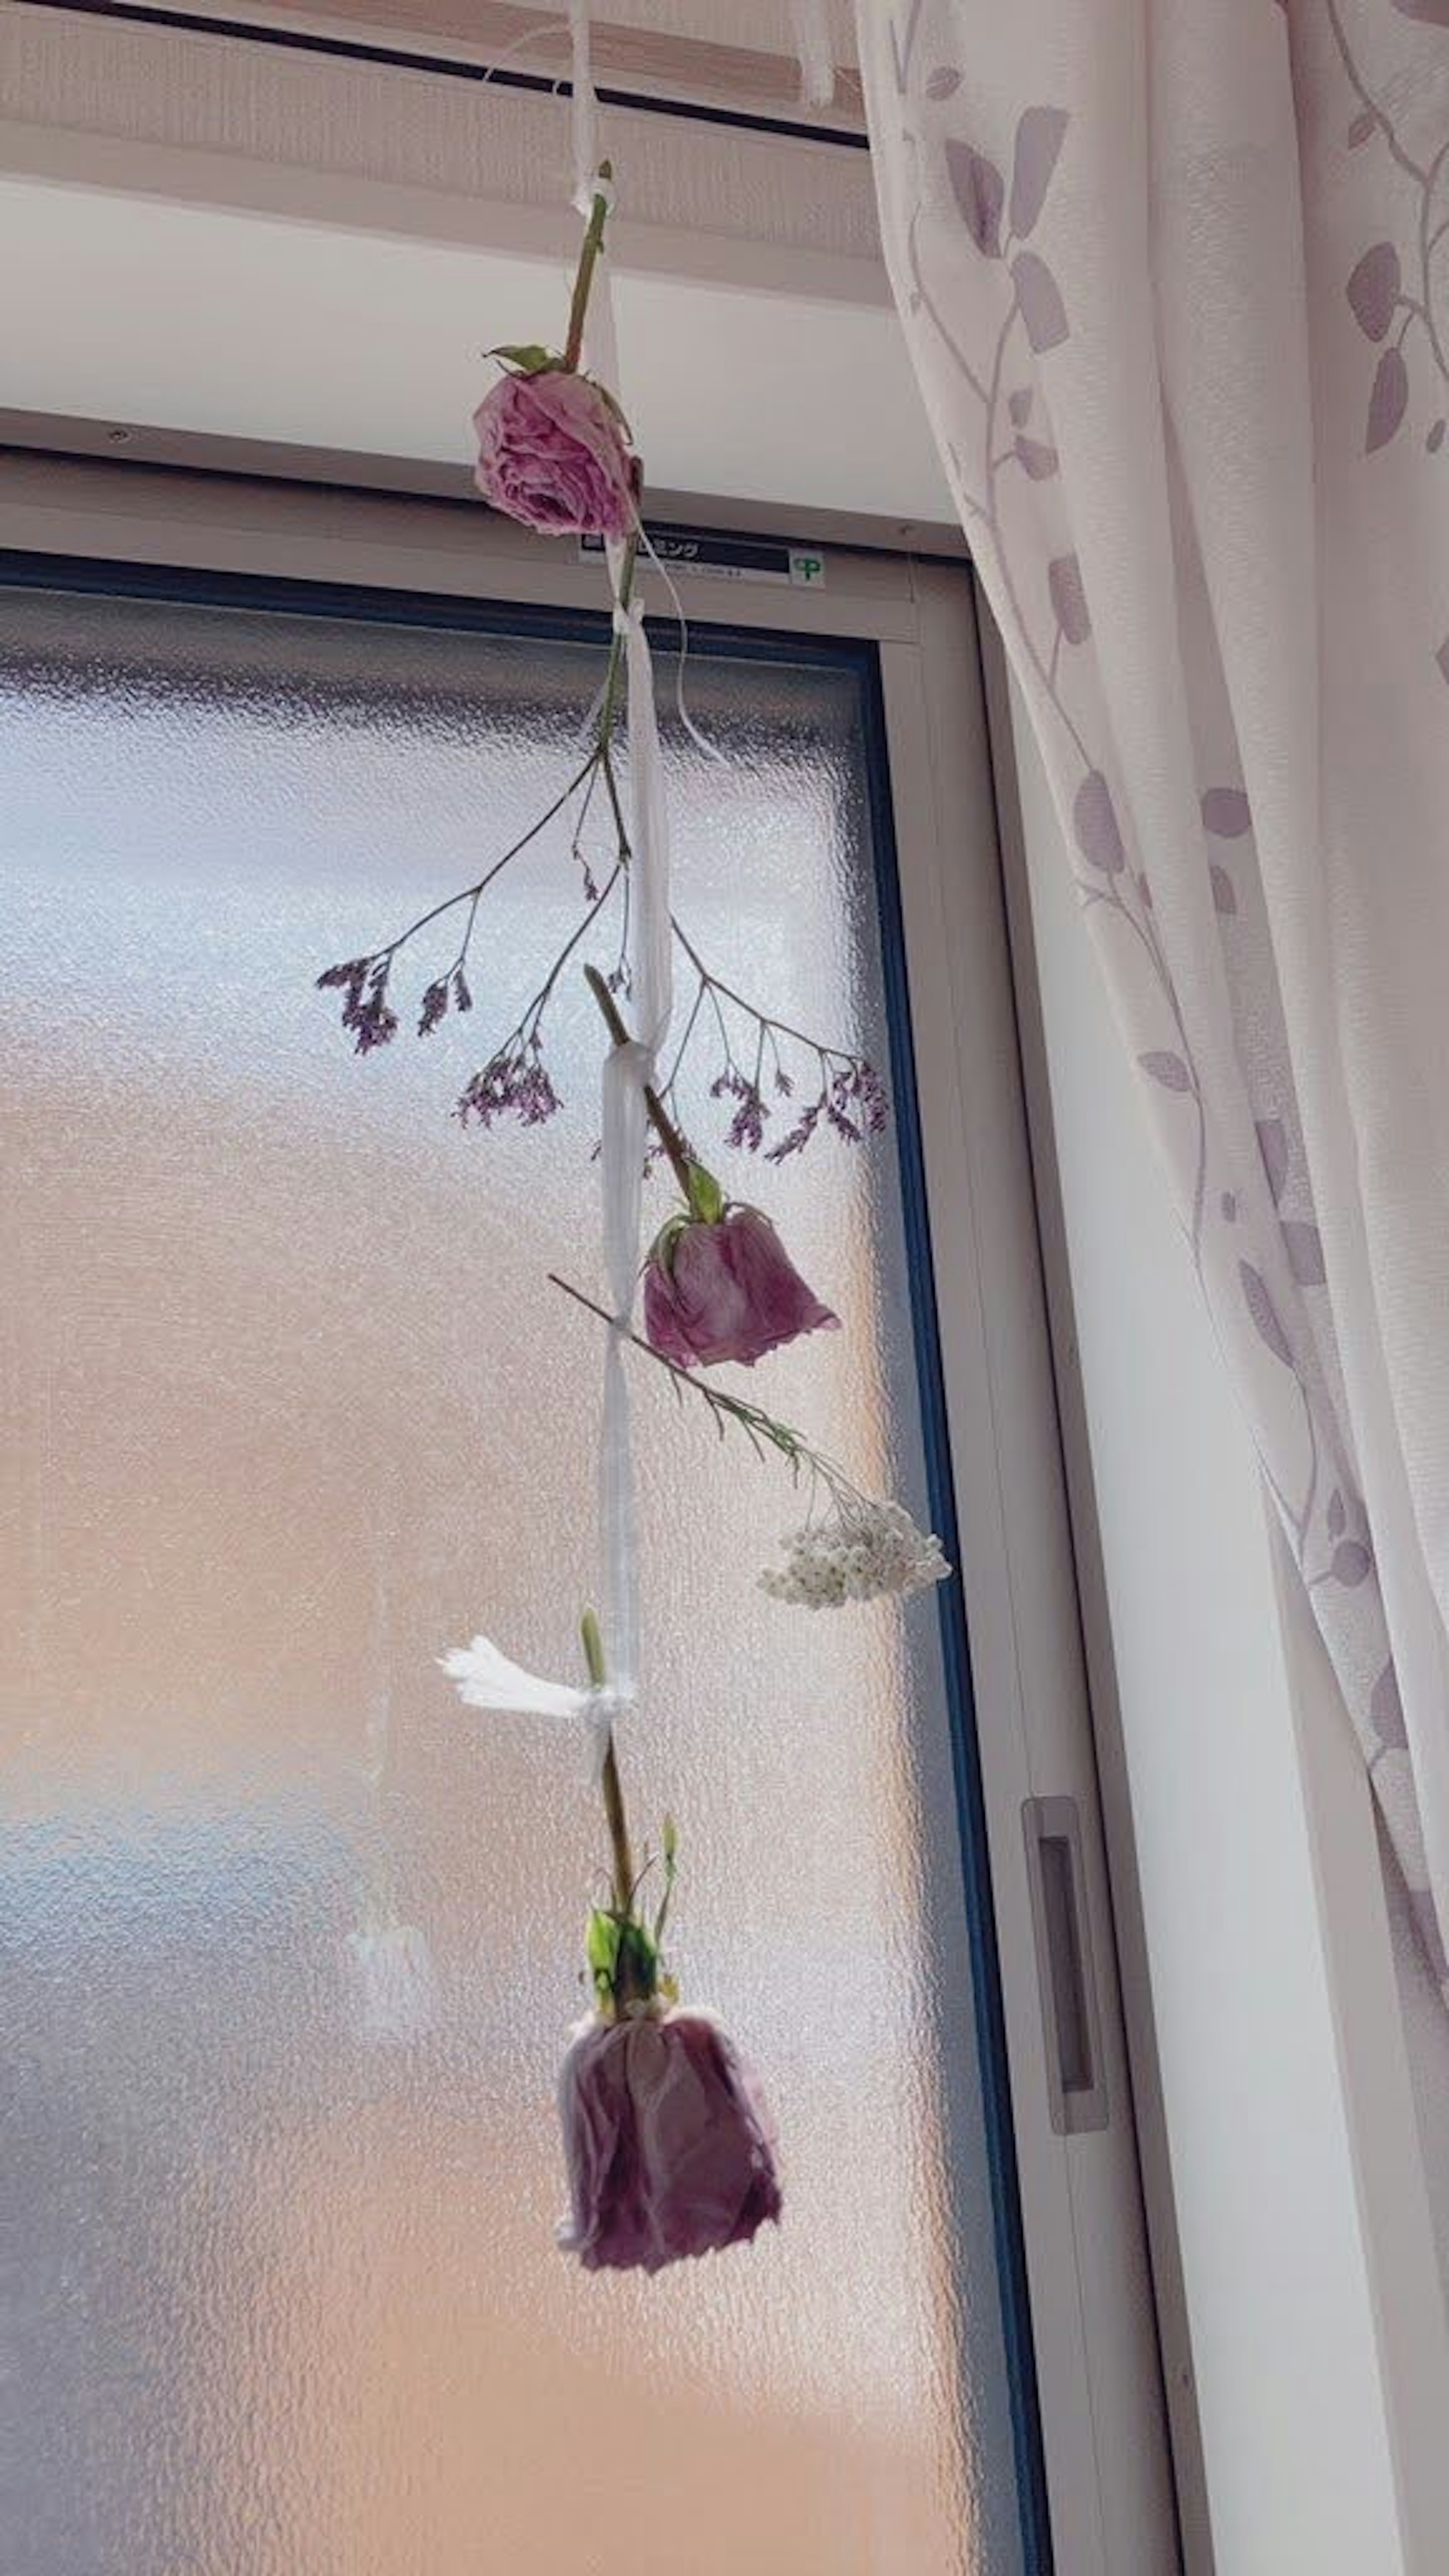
[560,2012,781,2272]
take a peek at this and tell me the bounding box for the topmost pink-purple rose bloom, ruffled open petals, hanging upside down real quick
[472,366,637,538]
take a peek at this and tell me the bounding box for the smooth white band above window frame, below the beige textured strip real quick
[0,180,951,520]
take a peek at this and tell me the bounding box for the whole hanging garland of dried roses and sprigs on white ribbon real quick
[317,151,949,2272]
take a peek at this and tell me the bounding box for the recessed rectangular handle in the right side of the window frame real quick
[1021,1798,1109,2138]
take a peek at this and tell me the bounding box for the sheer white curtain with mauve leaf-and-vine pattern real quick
[858,0,1449,1991]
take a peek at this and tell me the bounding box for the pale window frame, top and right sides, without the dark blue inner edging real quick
[0,456,1181,2576]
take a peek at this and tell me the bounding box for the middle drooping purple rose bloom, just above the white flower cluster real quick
[645,1208,840,1368]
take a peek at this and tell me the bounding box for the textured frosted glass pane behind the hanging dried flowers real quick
[0,592,1018,2576]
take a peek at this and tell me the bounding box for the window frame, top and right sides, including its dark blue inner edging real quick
[0,456,1181,2576]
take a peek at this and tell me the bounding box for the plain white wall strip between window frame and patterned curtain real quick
[1016,708,1449,2576]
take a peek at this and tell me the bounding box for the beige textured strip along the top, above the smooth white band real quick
[0,0,889,306]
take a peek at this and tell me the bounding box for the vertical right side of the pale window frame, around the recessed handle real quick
[882,564,1178,2576]
